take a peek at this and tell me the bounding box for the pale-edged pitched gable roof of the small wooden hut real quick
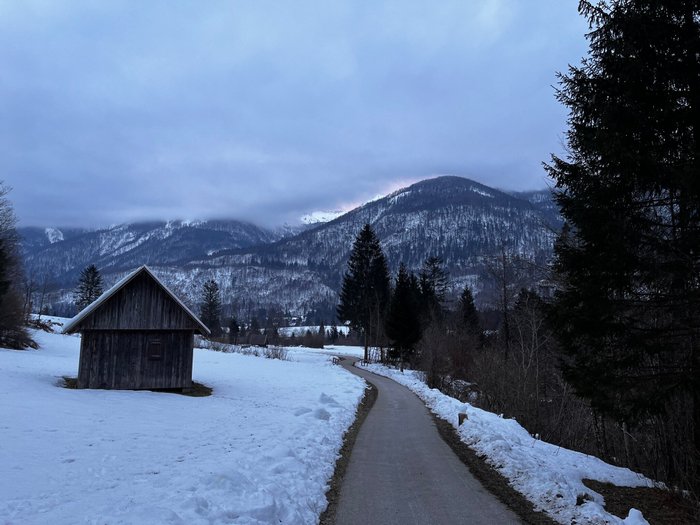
[63,266,210,335]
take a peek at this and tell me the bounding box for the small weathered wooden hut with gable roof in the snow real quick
[63,266,209,390]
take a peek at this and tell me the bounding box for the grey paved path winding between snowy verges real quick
[336,360,521,525]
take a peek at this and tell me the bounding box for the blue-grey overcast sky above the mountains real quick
[0,0,587,227]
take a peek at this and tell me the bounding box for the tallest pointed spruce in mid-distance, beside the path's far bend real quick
[337,224,390,360]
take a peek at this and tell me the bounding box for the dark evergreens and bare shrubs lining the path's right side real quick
[338,0,700,501]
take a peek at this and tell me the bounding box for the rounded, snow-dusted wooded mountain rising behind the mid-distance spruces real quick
[190,177,559,312]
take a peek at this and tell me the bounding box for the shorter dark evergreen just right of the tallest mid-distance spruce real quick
[386,263,422,371]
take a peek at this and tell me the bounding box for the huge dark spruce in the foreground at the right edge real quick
[547,0,700,488]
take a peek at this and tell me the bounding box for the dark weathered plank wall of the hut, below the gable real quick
[78,330,194,390]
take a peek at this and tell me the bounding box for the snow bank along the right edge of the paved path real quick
[362,364,653,525]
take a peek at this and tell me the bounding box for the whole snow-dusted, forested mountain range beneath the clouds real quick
[18,176,561,319]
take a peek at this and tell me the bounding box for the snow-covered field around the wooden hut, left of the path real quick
[0,324,364,525]
